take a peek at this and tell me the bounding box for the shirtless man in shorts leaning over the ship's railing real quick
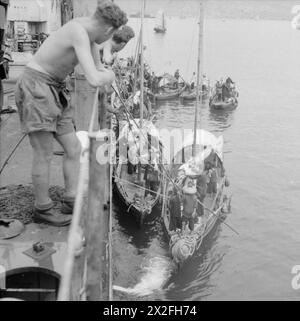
[16,1,127,226]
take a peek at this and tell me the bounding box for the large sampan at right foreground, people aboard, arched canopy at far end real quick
[162,130,229,265]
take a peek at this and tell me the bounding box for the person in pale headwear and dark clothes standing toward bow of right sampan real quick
[182,177,198,232]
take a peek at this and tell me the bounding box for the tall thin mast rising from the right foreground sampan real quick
[192,1,204,157]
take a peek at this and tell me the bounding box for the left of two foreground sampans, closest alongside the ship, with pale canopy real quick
[114,119,162,227]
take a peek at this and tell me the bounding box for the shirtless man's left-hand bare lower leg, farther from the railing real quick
[29,132,53,207]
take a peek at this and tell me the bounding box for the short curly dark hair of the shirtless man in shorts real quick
[94,0,128,29]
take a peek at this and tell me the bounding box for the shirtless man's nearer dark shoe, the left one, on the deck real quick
[34,203,71,226]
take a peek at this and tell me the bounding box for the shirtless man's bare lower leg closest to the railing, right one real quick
[55,132,81,198]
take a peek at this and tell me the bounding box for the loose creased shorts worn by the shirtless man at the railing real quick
[15,67,75,136]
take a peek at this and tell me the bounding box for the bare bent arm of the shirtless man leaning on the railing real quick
[72,22,115,87]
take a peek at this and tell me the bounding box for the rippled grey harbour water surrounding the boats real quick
[114,1,300,300]
